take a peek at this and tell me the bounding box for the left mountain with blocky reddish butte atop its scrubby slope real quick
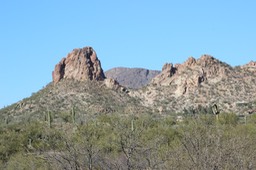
[0,47,148,124]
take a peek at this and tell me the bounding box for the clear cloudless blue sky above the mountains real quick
[0,0,256,108]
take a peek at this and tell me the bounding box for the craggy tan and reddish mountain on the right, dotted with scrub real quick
[133,55,256,114]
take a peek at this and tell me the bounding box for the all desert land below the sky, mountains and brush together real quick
[0,47,256,170]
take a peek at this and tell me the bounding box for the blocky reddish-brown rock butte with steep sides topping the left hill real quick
[52,47,105,84]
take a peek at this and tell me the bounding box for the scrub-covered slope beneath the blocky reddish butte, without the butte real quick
[0,80,148,124]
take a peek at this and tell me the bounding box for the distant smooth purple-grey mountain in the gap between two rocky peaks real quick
[105,67,160,89]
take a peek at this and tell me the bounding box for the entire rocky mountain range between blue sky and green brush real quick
[0,47,256,123]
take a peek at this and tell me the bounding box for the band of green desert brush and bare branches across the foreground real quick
[0,114,256,169]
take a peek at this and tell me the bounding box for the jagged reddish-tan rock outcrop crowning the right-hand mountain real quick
[152,55,231,89]
